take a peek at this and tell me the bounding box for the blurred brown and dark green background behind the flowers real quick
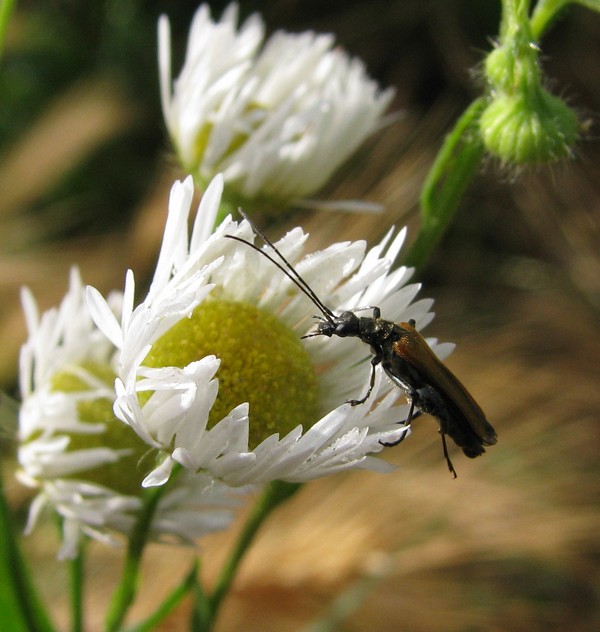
[0,0,600,632]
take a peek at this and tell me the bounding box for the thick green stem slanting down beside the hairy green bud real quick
[405,97,487,269]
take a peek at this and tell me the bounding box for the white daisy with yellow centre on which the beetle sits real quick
[83,177,452,485]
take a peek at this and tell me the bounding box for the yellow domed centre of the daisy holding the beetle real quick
[144,300,317,449]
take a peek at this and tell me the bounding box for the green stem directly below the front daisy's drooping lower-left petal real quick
[106,485,166,632]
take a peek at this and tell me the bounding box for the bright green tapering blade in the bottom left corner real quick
[0,472,54,632]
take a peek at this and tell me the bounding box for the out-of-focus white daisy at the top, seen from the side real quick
[159,4,393,201]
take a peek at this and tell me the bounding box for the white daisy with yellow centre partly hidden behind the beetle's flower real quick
[17,270,244,559]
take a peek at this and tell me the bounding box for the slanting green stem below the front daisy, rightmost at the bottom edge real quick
[197,481,301,632]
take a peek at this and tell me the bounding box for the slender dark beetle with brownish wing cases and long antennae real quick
[226,209,497,478]
